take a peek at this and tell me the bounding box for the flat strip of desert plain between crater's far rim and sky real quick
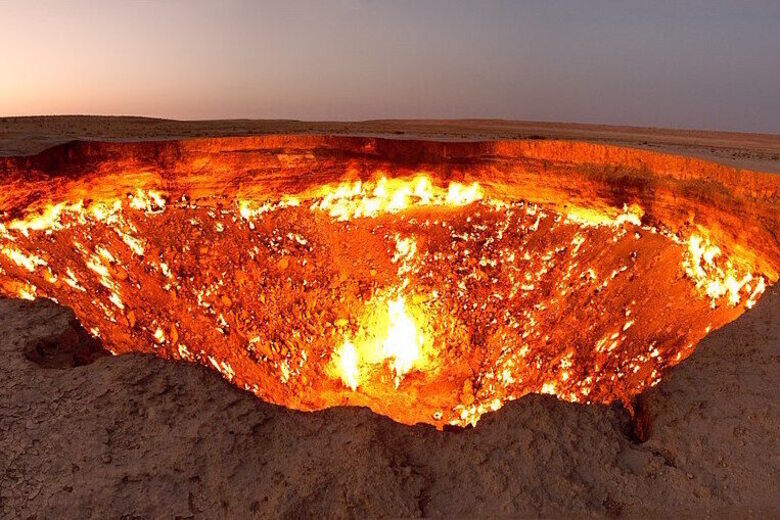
[0,116,780,173]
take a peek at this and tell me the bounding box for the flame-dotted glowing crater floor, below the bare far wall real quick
[0,138,776,426]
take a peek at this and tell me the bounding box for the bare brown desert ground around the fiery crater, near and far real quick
[0,117,780,518]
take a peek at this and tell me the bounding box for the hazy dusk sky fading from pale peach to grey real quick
[0,0,780,133]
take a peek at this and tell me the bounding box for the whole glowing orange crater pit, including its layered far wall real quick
[0,136,780,427]
